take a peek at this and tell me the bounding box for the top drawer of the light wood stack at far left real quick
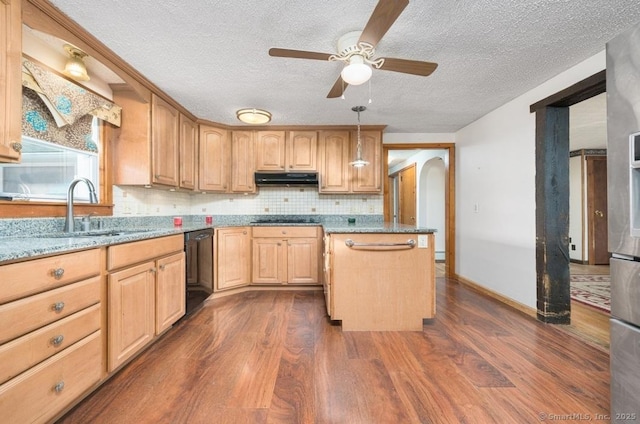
[0,249,100,303]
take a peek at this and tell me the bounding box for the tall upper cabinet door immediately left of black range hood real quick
[231,131,256,193]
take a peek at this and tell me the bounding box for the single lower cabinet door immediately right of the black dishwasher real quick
[214,227,251,290]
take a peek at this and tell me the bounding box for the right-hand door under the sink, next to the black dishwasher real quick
[156,252,187,334]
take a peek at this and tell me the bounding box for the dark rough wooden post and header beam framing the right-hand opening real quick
[530,71,606,324]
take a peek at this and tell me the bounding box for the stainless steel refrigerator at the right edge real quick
[607,19,640,423]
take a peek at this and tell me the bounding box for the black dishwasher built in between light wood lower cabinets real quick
[184,228,213,315]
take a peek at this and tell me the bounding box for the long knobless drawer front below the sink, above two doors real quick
[107,234,184,270]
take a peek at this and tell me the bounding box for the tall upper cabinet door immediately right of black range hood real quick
[318,131,351,193]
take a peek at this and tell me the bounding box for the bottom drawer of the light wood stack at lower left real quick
[0,330,102,423]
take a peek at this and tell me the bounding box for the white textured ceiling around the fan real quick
[46,0,640,133]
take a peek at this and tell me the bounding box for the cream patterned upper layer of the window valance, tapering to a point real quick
[22,59,122,127]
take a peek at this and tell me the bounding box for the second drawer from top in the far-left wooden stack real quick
[0,276,101,343]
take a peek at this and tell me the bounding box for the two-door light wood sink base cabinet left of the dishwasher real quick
[107,235,186,372]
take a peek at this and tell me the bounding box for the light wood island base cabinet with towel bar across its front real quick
[325,234,435,331]
